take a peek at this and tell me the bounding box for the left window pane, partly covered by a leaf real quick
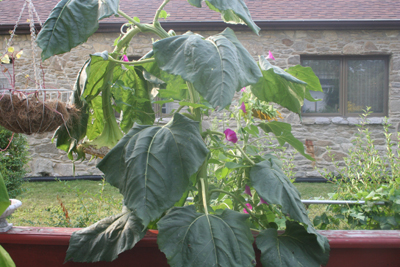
[302,59,340,113]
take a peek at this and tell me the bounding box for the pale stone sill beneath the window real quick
[301,117,385,125]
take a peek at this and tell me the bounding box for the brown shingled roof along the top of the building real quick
[0,0,400,31]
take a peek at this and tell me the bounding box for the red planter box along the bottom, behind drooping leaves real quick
[0,227,400,267]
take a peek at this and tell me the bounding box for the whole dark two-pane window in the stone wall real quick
[301,56,388,117]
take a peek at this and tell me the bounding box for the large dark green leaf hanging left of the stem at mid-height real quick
[97,114,208,225]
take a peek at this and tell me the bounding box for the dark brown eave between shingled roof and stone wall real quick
[0,19,400,35]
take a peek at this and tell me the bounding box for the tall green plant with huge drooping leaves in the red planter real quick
[37,0,329,267]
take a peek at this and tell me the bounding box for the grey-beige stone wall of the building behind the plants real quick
[0,30,400,177]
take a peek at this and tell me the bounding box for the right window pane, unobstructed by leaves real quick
[347,59,385,113]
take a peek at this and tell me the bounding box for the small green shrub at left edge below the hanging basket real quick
[0,126,28,198]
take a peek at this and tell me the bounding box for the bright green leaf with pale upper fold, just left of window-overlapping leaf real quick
[250,56,307,114]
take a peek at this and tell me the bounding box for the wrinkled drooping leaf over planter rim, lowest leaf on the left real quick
[65,207,147,262]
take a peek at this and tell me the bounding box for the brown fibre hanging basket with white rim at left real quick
[0,89,79,135]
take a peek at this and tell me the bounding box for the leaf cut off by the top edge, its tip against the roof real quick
[188,0,260,34]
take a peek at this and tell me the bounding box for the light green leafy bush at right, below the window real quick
[314,108,400,229]
